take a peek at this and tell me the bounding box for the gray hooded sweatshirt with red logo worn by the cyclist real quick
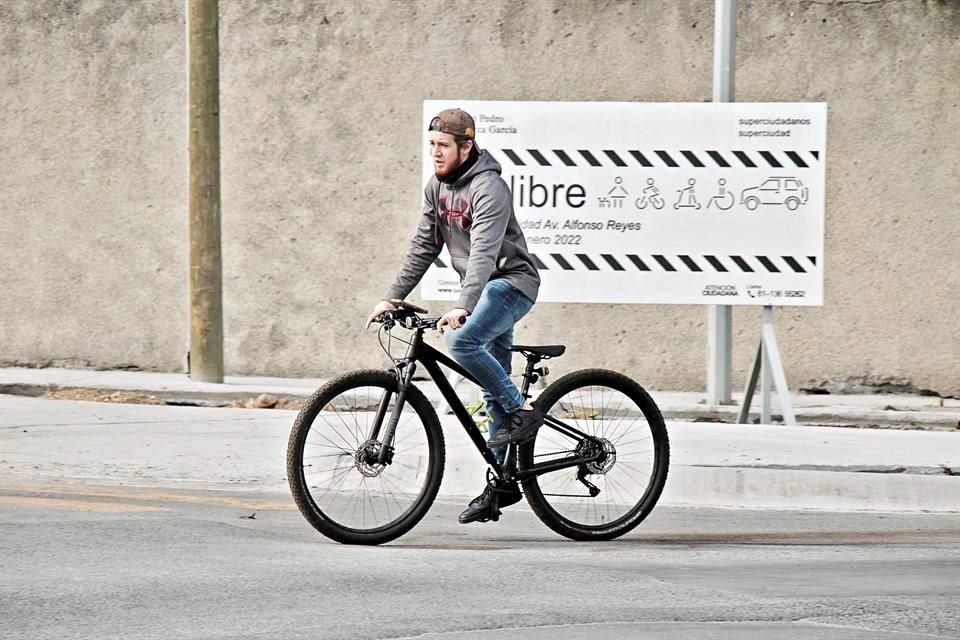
[384,151,540,313]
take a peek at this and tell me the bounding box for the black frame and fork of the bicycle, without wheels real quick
[370,328,603,480]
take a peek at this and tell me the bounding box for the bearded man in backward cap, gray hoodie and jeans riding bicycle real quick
[367,109,543,524]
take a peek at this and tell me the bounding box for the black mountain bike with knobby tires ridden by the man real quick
[287,301,670,544]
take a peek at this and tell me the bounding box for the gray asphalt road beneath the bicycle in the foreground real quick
[0,482,960,640]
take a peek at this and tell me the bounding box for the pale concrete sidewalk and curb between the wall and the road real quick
[0,369,960,512]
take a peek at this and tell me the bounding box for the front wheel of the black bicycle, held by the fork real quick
[287,370,444,544]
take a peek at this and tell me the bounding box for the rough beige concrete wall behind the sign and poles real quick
[0,0,960,394]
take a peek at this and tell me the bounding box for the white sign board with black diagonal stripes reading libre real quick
[422,100,827,305]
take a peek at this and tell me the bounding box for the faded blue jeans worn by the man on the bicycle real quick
[445,280,533,462]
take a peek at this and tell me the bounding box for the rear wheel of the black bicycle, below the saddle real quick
[518,369,670,540]
